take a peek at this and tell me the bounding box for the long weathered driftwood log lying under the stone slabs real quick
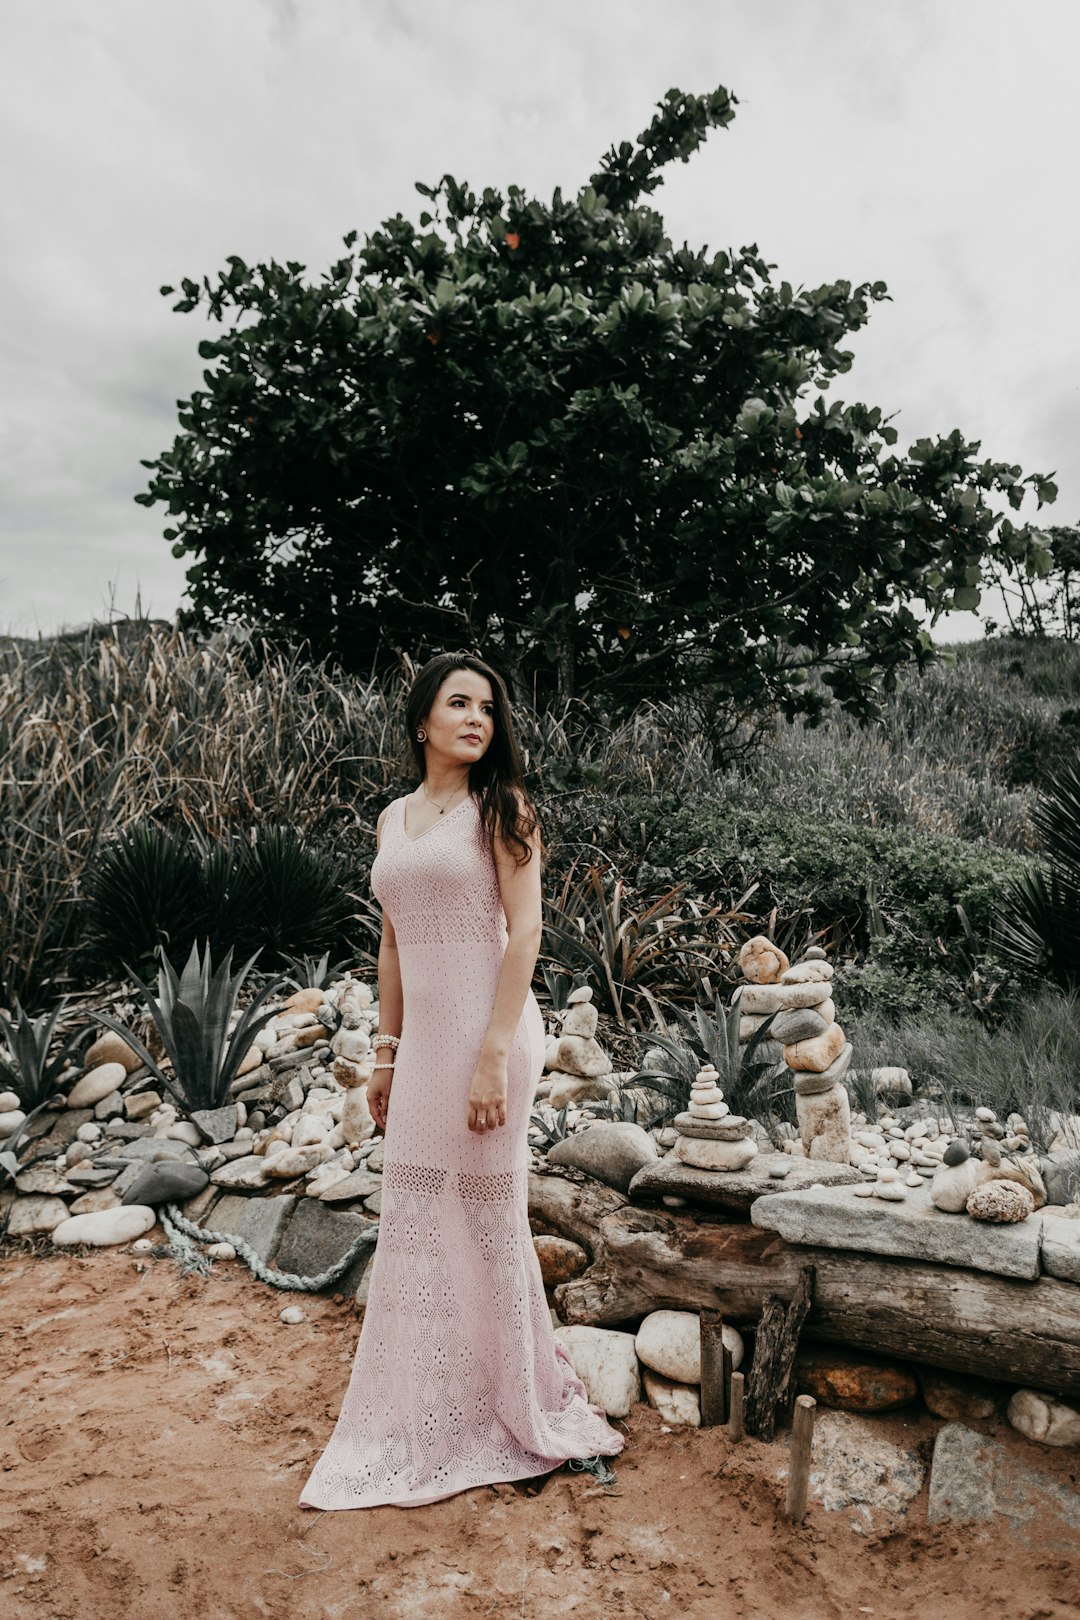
[529,1173,1080,1395]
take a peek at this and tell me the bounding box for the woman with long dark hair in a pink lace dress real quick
[300,653,623,1508]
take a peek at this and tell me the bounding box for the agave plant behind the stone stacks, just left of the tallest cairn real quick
[628,995,779,1119]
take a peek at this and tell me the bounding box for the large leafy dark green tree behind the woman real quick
[136,87,1056,718]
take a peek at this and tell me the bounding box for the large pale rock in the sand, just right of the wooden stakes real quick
[799,1411,926,1529]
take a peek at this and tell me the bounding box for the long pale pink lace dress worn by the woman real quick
[300,795,623,1508]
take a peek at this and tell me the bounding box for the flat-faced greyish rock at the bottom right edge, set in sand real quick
[926,1422,1080,1552]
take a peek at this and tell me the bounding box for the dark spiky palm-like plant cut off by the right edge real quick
[996,755,1080,990]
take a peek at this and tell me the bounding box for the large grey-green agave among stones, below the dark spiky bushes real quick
[92,941,282,1123]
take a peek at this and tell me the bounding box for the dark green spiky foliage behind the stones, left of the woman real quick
[86,821,355,970]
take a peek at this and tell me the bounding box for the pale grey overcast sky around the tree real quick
[0,0,1080,637]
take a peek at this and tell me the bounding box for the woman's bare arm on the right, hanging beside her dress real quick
[468,800,542,1131]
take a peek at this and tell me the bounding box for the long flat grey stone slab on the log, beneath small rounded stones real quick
[750,1178,1043,1277]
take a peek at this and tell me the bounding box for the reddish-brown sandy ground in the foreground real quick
[0,1228,1080,1620]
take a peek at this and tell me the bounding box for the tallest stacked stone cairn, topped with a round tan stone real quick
[732,935,852,1165]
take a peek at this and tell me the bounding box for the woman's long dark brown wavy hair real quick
[405,653,542,867]
